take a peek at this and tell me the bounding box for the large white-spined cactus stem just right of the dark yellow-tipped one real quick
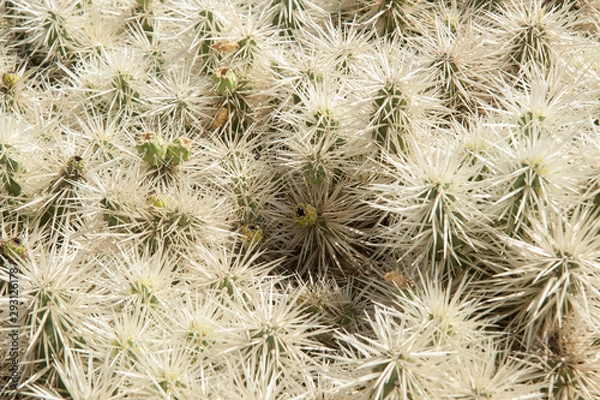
[373,138,490,275]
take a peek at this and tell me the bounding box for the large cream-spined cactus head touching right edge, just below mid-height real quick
[494,209,600,347]
